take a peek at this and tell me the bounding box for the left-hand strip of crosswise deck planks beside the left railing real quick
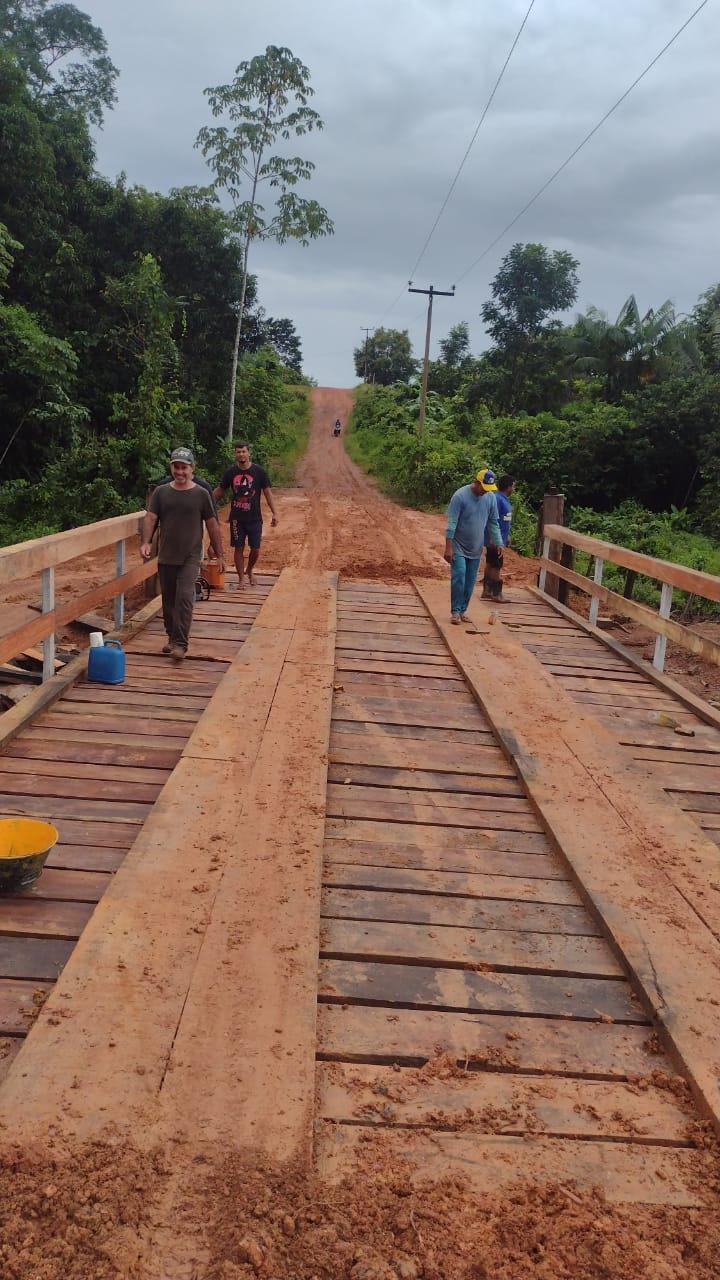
[0,573,277,1078]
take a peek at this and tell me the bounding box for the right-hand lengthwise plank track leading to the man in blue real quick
[419,582,720,1128]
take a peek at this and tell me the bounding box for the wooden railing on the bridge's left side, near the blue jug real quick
[0,511,158,680]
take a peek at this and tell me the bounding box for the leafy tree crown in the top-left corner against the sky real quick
[0,0,118,124]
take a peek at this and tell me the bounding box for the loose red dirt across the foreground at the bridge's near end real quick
[0,1137,720,1280]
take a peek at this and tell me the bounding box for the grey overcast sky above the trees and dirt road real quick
[77,0,720,387]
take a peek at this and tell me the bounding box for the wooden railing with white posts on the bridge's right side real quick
[538,524,720,671]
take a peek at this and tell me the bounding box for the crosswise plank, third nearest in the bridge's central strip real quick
[318,1005,657,1079]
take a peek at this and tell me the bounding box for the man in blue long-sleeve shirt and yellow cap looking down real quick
[445,470,502,625]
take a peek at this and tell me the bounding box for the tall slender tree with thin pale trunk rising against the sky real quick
[196,45,334,440]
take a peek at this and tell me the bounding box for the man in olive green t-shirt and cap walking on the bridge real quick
[140,449,223,662]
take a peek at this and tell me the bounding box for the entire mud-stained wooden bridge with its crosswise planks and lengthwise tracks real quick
[0,517,720,1204]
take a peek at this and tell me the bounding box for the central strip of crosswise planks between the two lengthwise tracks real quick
[316,582,701,1204]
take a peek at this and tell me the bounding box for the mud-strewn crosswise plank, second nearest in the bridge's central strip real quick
[318,1062,688,1144]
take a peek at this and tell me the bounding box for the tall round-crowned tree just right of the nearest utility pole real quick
[480,244,579,412]
